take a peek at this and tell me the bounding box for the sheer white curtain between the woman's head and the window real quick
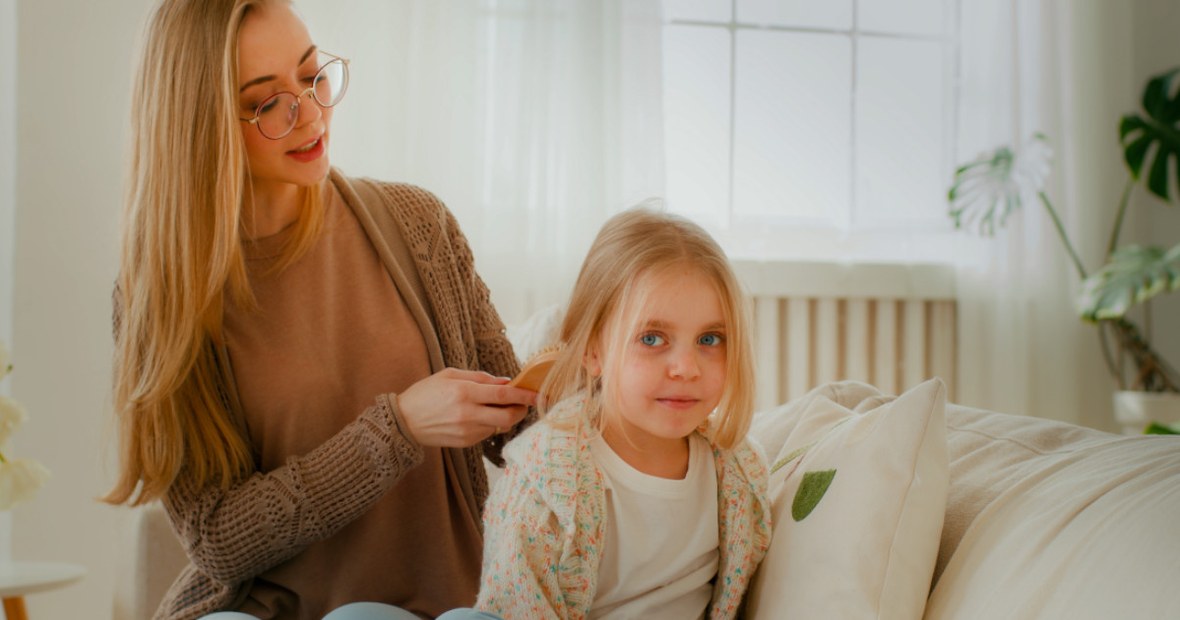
[297,0,663,322]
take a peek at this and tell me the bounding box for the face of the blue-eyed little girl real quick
[588,267,727,451]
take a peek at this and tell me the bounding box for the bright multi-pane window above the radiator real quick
[663,0,958,261]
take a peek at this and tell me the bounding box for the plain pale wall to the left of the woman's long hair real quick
[14,0,148,619]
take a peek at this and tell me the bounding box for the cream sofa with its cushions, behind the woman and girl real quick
[114,379,1180,620]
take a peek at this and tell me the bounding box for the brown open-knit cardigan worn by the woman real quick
[156,170,533,620]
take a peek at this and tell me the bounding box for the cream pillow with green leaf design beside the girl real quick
[747,379,948,619]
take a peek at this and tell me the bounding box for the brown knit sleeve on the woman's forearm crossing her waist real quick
[164,396,424,583]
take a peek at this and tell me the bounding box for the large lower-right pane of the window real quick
[856,37,949,227]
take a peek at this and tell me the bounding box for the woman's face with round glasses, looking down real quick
[237,2,332,190]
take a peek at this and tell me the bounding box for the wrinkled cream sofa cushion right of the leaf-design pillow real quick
[926,406,1180,620]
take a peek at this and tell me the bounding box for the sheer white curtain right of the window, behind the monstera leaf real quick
[958,0,1135,429]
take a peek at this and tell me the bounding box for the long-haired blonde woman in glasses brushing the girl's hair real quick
[105,0,536,620]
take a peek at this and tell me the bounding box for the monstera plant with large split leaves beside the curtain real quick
[948,67,1180,425]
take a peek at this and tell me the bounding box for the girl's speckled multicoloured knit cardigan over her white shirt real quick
[476,399,771,619]
